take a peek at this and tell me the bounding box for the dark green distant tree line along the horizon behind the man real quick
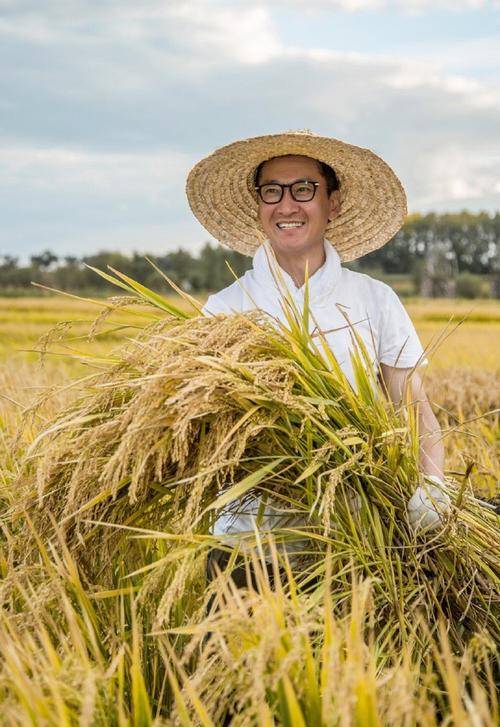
[0,212,500,297]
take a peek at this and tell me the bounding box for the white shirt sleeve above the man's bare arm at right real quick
[378,286,429,368]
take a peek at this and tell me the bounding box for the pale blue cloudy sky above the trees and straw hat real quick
[0,0,500,259]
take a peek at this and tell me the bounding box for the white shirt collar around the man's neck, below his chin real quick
[253,240,342,303]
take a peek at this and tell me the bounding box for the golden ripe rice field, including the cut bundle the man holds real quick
[0,297,500,727]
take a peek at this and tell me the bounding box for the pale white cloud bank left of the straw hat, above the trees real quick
[0,146,208,257]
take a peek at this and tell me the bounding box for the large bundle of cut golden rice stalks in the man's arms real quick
[4,280,500,672]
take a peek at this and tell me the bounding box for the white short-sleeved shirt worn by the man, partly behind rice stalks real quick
[203,241,427,534]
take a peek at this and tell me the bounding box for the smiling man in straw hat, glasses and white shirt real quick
[187,132,449,532]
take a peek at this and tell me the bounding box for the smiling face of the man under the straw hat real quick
[257,156,340,264]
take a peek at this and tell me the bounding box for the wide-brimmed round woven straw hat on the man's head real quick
[186,130,406,261]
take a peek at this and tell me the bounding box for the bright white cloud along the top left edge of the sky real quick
[0,0,282,65]
